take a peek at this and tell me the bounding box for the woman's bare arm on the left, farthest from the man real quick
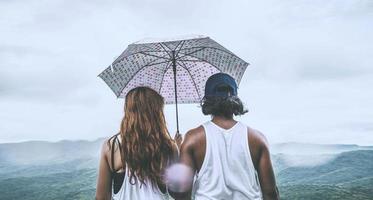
[96,140,111,200]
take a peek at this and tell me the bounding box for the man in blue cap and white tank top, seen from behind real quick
[176,73,279,200]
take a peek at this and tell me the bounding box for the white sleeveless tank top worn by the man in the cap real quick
[193,121,262,200]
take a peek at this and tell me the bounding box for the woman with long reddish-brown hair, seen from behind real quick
[96,87,178,200]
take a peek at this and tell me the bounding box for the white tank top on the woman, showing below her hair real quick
[111,170,172,200]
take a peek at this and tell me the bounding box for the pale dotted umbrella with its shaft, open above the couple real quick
[99,36,248,132]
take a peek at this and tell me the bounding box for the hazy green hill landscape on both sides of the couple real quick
[0,139,373,200]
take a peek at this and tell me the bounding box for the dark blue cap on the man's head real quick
[205,73,237,97]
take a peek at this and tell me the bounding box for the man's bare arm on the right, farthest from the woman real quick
[248,129,280,200]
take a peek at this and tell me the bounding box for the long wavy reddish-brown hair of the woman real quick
[120,87,176,186]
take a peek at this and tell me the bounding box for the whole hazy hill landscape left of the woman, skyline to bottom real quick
[0,139,104,200]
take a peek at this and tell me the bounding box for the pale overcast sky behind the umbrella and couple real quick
[0,0,373,145]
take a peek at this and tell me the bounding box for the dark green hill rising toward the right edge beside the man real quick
[276,150,373,200]
